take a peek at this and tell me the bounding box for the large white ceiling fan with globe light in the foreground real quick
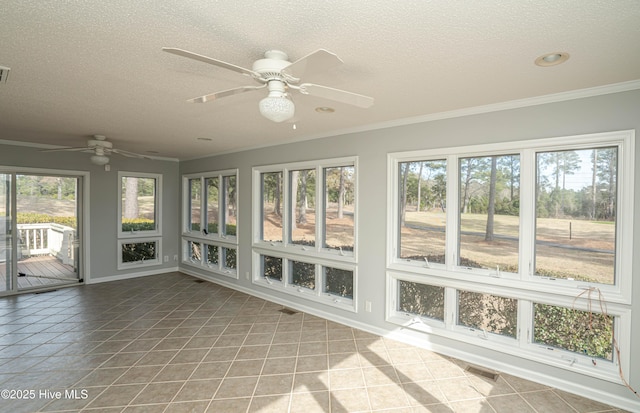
[162,47,373,122]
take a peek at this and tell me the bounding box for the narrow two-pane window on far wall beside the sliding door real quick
[118,171,162,269]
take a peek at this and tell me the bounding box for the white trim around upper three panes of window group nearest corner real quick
[182,169,240,245]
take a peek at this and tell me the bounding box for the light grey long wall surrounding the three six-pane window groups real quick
[180,90,640,411]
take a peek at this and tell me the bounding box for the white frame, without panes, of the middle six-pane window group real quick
[252,156,359,312]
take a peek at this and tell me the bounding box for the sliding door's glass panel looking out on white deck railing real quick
[14,174,82,291]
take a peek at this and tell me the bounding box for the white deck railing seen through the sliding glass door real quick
[18,223,76,265]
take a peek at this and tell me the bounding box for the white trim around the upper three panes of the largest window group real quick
[387,130,635,304]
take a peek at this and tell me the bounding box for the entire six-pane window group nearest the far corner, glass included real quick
[182,170,238,278]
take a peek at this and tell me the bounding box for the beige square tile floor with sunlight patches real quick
[0,273,632,413]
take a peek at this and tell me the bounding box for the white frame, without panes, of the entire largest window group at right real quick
[386,130,635,383]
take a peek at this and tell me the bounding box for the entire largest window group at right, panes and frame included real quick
[387,131,634,381]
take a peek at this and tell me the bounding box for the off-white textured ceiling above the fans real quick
[0,0,640,159]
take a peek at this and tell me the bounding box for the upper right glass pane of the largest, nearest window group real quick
[535,147,618,285]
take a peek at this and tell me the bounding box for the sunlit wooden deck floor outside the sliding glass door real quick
[0,255,78,292]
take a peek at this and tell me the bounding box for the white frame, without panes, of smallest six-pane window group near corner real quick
[181,168,240,279]
